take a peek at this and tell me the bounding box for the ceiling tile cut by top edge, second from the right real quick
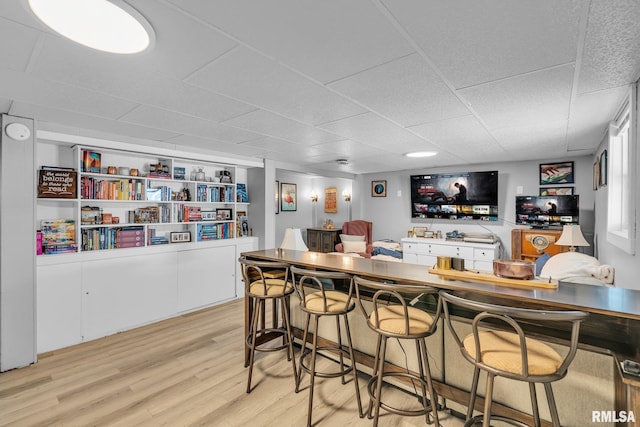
[382,0,580,88]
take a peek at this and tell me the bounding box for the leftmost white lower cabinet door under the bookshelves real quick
[37,263,82,353]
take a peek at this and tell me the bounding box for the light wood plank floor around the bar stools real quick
[0,300,463,427]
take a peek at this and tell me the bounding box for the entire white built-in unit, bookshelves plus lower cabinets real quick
[34,132,262,353]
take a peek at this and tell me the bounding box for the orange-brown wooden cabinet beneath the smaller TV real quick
[511,228,569,262]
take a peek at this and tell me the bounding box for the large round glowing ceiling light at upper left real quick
[28,0,154,54]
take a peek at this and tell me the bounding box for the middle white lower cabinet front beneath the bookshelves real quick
[82,252,177,339]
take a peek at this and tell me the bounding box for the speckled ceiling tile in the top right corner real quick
[578,0,640,93]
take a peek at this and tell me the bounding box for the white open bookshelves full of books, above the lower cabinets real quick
[37,145,254,254]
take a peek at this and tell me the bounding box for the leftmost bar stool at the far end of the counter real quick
[238,257,297,393]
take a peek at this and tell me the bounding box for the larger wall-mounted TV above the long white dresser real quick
[411,171,498,221]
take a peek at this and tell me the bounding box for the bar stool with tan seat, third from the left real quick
[353,276,442,427]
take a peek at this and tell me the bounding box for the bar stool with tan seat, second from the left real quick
[291,266,364,426]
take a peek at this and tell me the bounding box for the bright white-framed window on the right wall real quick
[606,84,637,255]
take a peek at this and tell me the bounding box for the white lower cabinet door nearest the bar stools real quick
[178,245,237,312]
